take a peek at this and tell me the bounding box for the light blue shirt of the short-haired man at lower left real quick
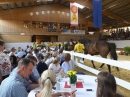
[0,72,28,97]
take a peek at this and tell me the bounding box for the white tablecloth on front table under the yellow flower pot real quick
[29,75,97,97]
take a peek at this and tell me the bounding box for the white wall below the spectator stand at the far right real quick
[108,40,130,48]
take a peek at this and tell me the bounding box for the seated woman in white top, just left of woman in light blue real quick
[49,57,61,74]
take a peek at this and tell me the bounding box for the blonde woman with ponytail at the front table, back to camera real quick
[28,69,74,97]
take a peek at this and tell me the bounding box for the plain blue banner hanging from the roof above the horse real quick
[93,0,102,28]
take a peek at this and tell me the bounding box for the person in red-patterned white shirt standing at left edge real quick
[0,40,12,82]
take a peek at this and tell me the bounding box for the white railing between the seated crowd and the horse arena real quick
[64,51,130,90]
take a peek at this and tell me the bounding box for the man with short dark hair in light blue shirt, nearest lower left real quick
[0,58,34,97]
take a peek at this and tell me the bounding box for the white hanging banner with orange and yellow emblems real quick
[70,2,78,26]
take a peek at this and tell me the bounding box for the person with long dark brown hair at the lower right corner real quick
[95,72,123,97]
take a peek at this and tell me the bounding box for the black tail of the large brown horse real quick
[109,43,118,60]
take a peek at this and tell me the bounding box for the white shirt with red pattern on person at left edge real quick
[0,52,11,76]
